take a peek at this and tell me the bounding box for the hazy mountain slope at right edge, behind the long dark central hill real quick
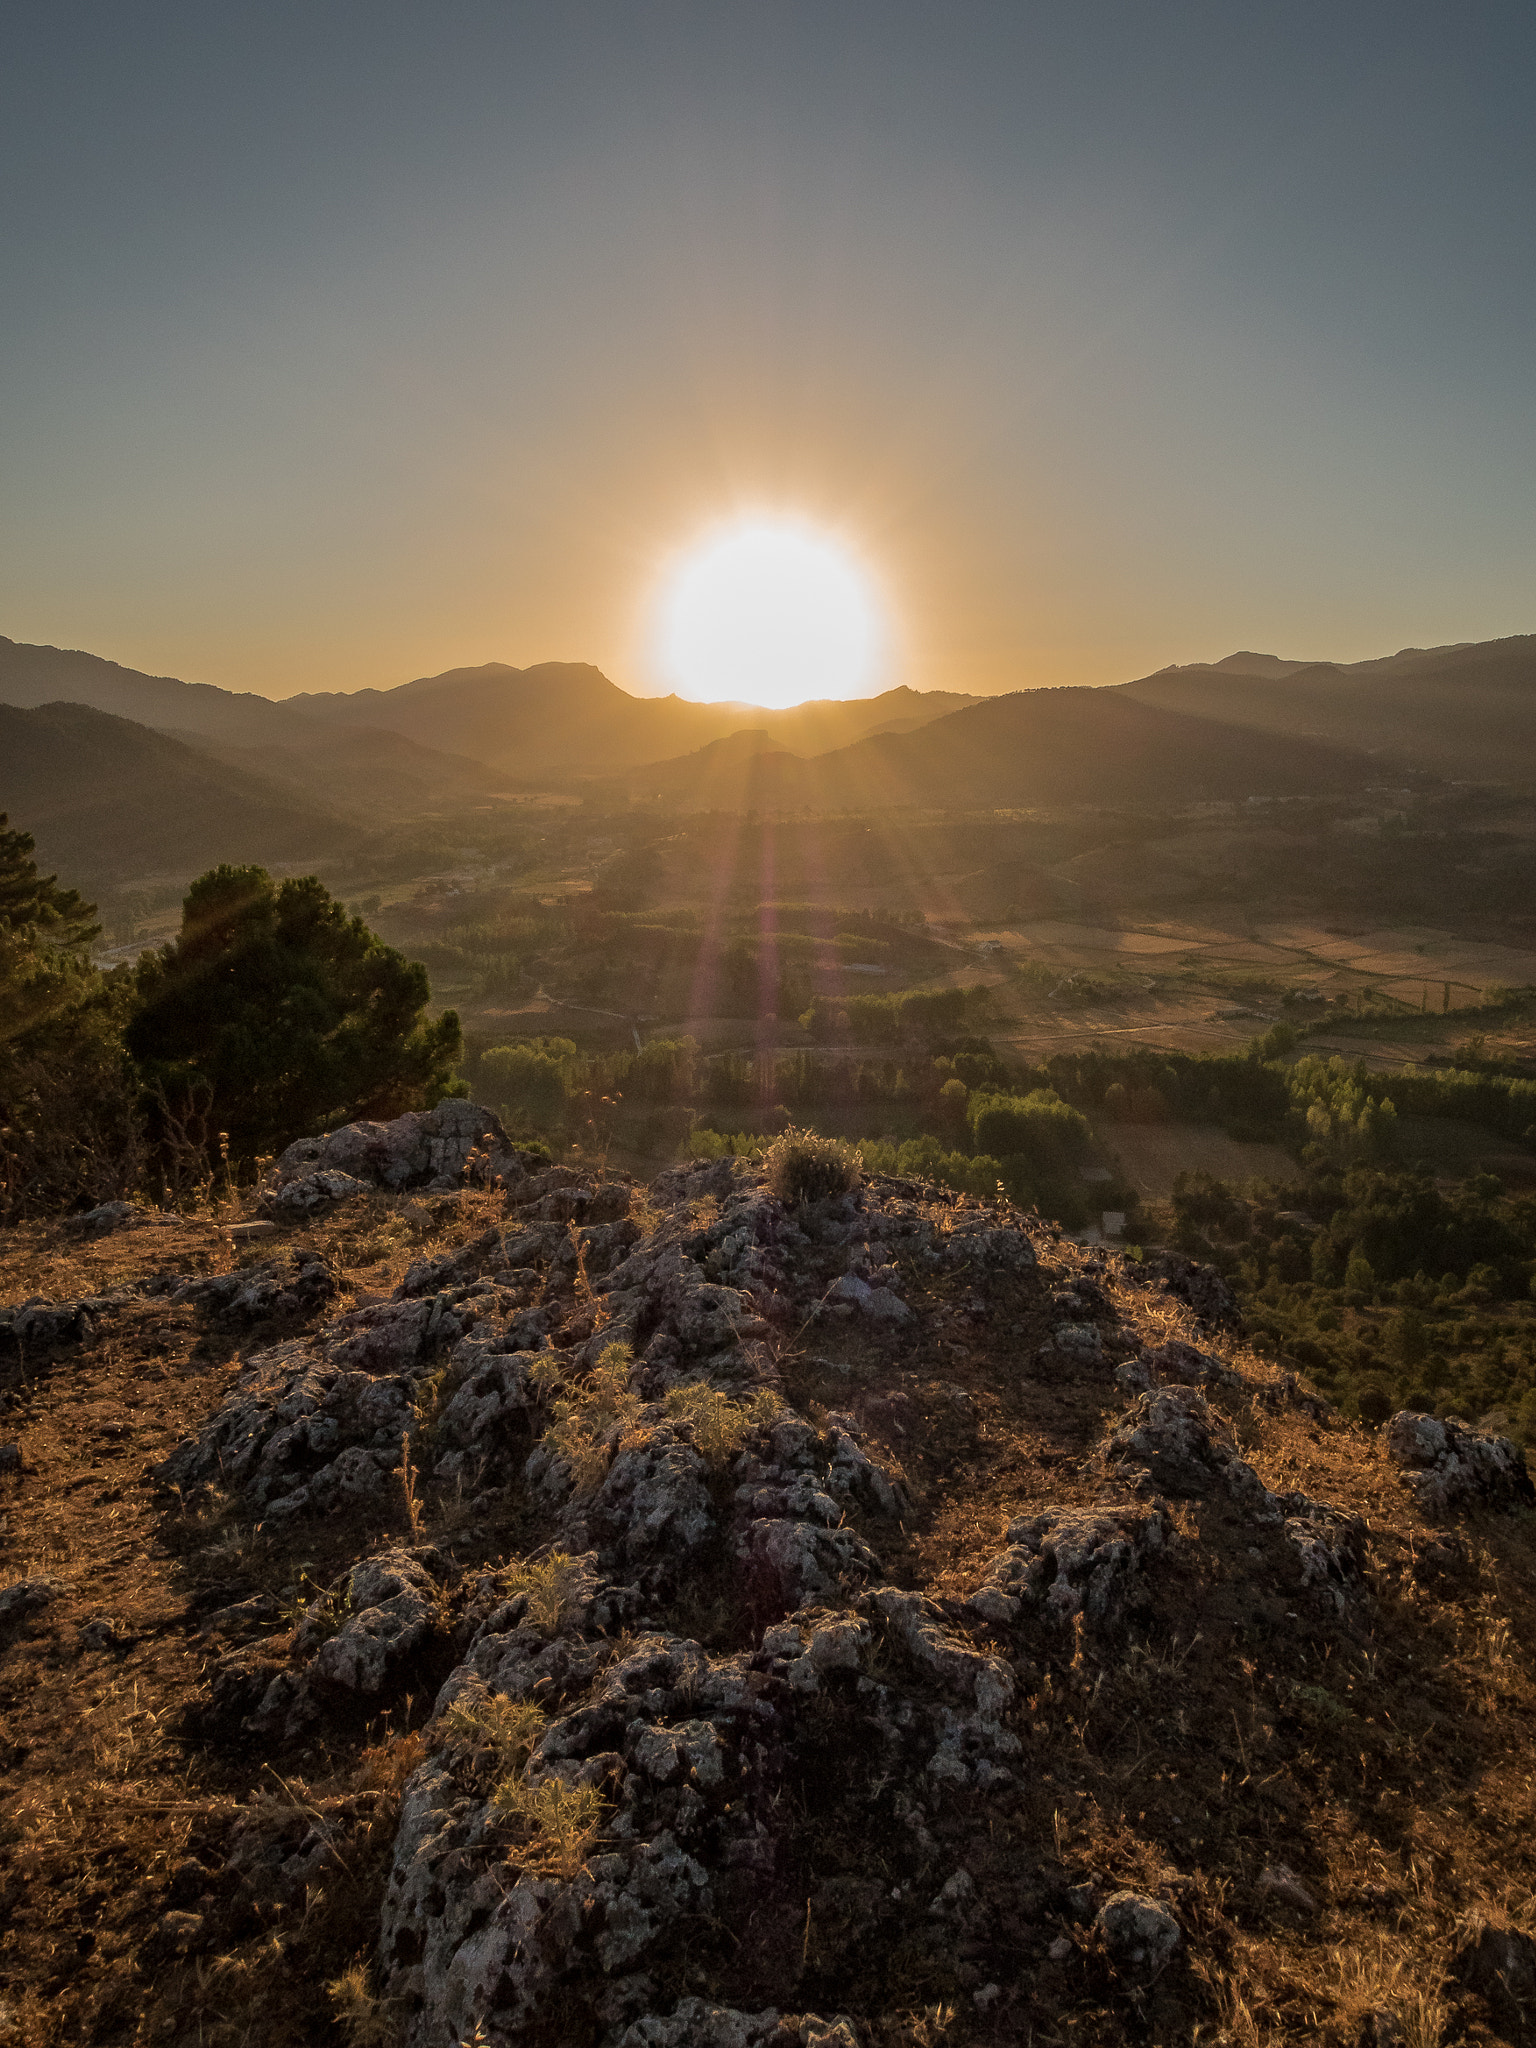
[1114,633,1536,780]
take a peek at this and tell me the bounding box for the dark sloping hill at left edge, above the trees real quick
[0,705,352,895]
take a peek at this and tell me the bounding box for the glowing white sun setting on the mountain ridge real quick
[659,518,885,707]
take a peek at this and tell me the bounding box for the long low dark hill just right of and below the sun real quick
[629,688,1374,811]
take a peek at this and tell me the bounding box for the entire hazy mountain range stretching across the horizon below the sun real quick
[0,635,1536,889]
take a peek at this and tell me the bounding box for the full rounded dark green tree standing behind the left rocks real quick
[125,866,465,1159]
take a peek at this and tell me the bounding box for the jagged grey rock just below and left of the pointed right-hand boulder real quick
[967,1507,1167,1628]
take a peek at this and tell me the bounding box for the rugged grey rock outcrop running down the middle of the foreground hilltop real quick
[147,1112,1409,2048]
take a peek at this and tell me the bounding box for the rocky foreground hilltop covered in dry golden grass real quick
[0,1104,1536,2048]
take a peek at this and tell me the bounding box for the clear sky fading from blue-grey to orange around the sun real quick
[0,0,1536,696]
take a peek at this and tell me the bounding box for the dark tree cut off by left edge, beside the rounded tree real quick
[0,813,141,1221]
